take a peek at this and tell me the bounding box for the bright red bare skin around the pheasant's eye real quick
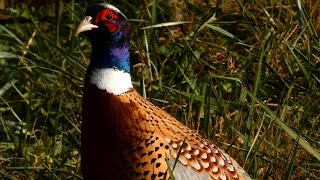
[96,9,118,33]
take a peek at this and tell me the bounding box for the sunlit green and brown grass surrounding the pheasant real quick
[0,0,320,179]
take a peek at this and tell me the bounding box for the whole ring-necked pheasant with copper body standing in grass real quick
[76,3,251,180]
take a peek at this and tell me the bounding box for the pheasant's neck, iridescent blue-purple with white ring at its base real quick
[87,39,132,95]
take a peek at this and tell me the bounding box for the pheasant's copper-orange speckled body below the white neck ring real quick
[82,84,250,179]
